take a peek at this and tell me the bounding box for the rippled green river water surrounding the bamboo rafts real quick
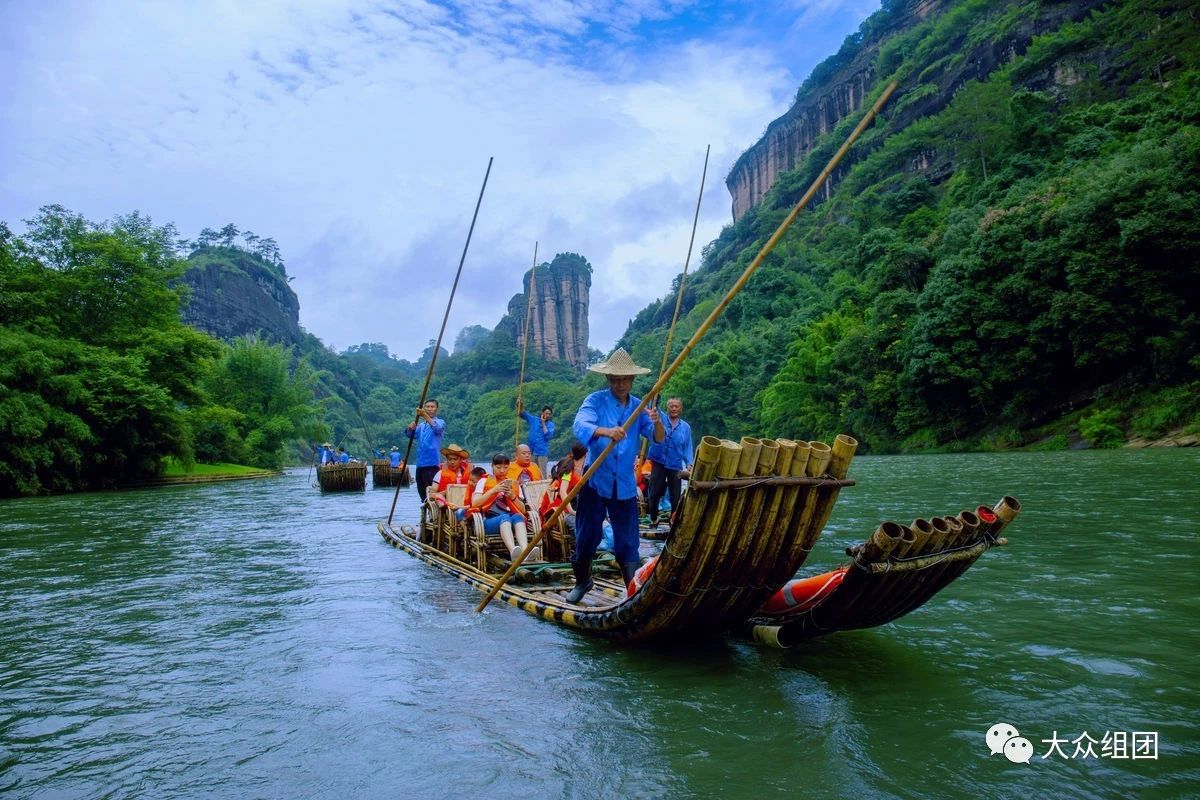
[0,450,1200,800]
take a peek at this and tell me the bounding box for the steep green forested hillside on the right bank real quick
[622,0,1200,451]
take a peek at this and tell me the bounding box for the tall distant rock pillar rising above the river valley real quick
[496,253,592,372]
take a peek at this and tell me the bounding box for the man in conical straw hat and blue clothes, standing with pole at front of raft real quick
[566,348,666,603]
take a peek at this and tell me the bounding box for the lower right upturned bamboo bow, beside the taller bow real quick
[737,497,1021,648]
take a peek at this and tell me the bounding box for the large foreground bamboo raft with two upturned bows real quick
[378,435,1020,646]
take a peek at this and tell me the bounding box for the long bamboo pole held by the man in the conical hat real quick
[475,82,898,612]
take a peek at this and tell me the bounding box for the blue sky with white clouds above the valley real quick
[0,0,880,359]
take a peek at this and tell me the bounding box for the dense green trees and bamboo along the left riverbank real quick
[0,206,319,495]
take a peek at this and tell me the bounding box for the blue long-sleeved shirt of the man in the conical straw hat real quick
[572,389,654,500]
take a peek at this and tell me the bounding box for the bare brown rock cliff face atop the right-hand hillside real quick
[725,0,1105,221]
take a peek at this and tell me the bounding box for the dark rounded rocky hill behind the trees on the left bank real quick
[184,247,300,345]
